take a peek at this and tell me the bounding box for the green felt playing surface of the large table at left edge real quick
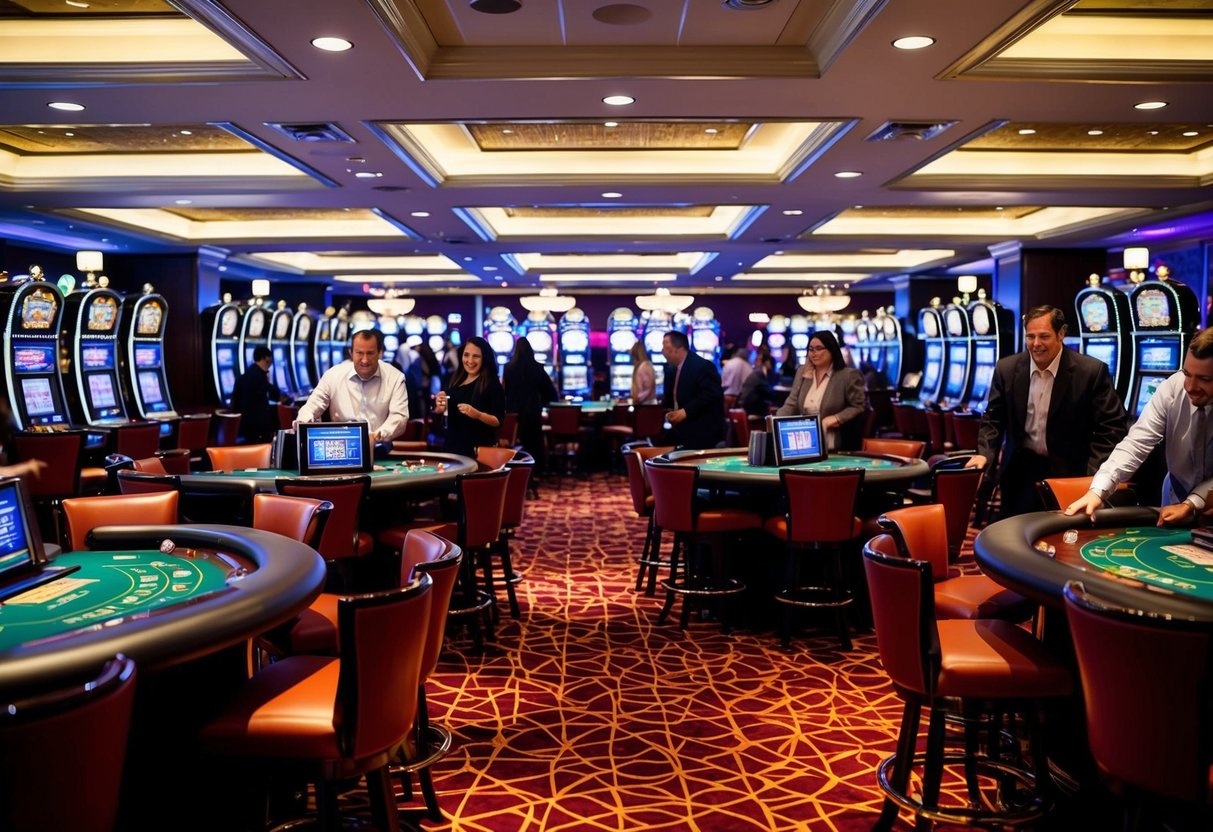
[0,549,237,653]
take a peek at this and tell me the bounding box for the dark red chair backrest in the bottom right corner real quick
[1065,581,1213,805]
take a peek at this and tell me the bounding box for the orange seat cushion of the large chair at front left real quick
[200,656,341,759]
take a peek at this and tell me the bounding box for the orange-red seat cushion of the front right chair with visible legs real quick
[935,619,1072,699]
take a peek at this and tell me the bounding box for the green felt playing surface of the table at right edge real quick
[1081,528,1213,600]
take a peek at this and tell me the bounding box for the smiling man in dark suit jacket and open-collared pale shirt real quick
[967,306,1128,517]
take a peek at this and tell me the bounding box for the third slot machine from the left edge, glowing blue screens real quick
[118,285,177,435]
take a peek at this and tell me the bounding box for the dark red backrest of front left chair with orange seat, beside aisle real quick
[334,575,433,759]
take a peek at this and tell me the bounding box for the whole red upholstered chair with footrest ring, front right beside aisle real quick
[864,535,1072,830]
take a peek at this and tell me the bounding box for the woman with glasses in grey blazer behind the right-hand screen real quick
[775,330,867,451]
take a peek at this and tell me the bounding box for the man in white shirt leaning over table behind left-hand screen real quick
[296,330,409,444]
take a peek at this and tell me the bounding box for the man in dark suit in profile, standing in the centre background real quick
[661,330,724,450]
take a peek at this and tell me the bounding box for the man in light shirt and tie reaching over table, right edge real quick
[1065,326,1213,525]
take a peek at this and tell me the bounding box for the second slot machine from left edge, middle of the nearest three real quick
[59,278,130,446]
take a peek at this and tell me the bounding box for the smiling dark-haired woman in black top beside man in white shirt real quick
[434,336,506,457]
